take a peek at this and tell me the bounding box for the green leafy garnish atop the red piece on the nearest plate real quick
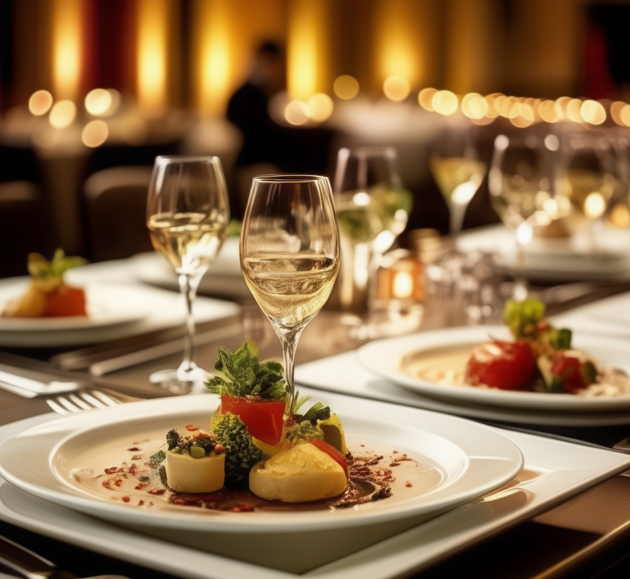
[206,341,287,400]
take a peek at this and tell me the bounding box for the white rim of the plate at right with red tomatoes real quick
[357,325,630,412]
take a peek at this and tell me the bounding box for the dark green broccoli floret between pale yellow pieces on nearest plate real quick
[210,412,262,487]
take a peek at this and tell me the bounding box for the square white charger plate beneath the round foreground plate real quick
[0,412,630,579]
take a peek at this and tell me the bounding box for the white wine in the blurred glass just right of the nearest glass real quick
[335,185,412,244]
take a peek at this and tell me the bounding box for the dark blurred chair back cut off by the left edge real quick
[0,181,55,277]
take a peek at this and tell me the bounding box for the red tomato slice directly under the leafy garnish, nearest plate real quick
[221,394,286,445]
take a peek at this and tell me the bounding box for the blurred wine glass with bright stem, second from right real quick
[488,131,570,300]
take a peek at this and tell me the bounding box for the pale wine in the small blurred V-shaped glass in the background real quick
[431,157,487,207]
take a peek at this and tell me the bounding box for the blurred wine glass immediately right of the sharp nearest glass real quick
[334,147,413,315]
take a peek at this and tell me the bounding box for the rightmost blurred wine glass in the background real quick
[562,130,625,254]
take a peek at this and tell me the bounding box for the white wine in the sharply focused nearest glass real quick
[242,253,339,329]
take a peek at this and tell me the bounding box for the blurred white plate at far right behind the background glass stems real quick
[457,225,630,281]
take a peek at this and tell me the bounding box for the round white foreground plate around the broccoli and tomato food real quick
[0,394,523,533]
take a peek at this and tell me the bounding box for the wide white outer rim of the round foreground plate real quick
[0,392,523,532]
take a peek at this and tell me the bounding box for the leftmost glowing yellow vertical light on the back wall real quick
[52,0,84,100]
